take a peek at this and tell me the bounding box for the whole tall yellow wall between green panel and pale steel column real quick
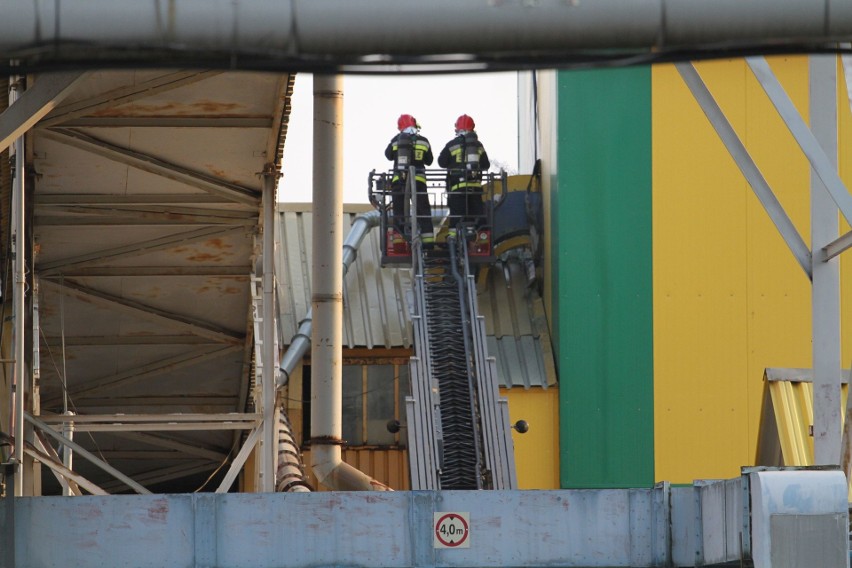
[652,58,810,483]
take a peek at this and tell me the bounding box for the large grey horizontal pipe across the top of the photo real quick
[0,0,852,57]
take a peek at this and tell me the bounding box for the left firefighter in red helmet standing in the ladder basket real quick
[385,114,435,246]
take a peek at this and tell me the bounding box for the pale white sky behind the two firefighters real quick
[278,72,518,203]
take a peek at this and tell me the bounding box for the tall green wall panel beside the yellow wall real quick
[551,67,654,488]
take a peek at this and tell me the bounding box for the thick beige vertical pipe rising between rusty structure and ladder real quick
[311,75,343,485]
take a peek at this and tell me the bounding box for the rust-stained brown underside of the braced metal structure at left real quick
[29,69,294,493]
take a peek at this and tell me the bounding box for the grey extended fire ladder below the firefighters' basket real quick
[406,239,517,489]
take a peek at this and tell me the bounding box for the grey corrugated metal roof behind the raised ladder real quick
[276,204,556,388]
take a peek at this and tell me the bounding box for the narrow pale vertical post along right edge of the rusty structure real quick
[260,169,278,493]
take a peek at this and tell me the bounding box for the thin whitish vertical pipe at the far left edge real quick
[11,78,26,497]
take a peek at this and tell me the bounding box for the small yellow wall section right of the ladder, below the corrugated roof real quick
[500,387,559,489]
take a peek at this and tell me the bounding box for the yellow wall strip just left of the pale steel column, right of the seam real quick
[738,57,811,465]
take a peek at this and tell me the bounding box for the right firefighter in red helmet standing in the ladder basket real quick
[438,114,491,236]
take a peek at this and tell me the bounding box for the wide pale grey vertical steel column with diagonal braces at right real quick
[810,55,841,465]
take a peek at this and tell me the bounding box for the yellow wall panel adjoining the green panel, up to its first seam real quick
[652,62,747,483]
